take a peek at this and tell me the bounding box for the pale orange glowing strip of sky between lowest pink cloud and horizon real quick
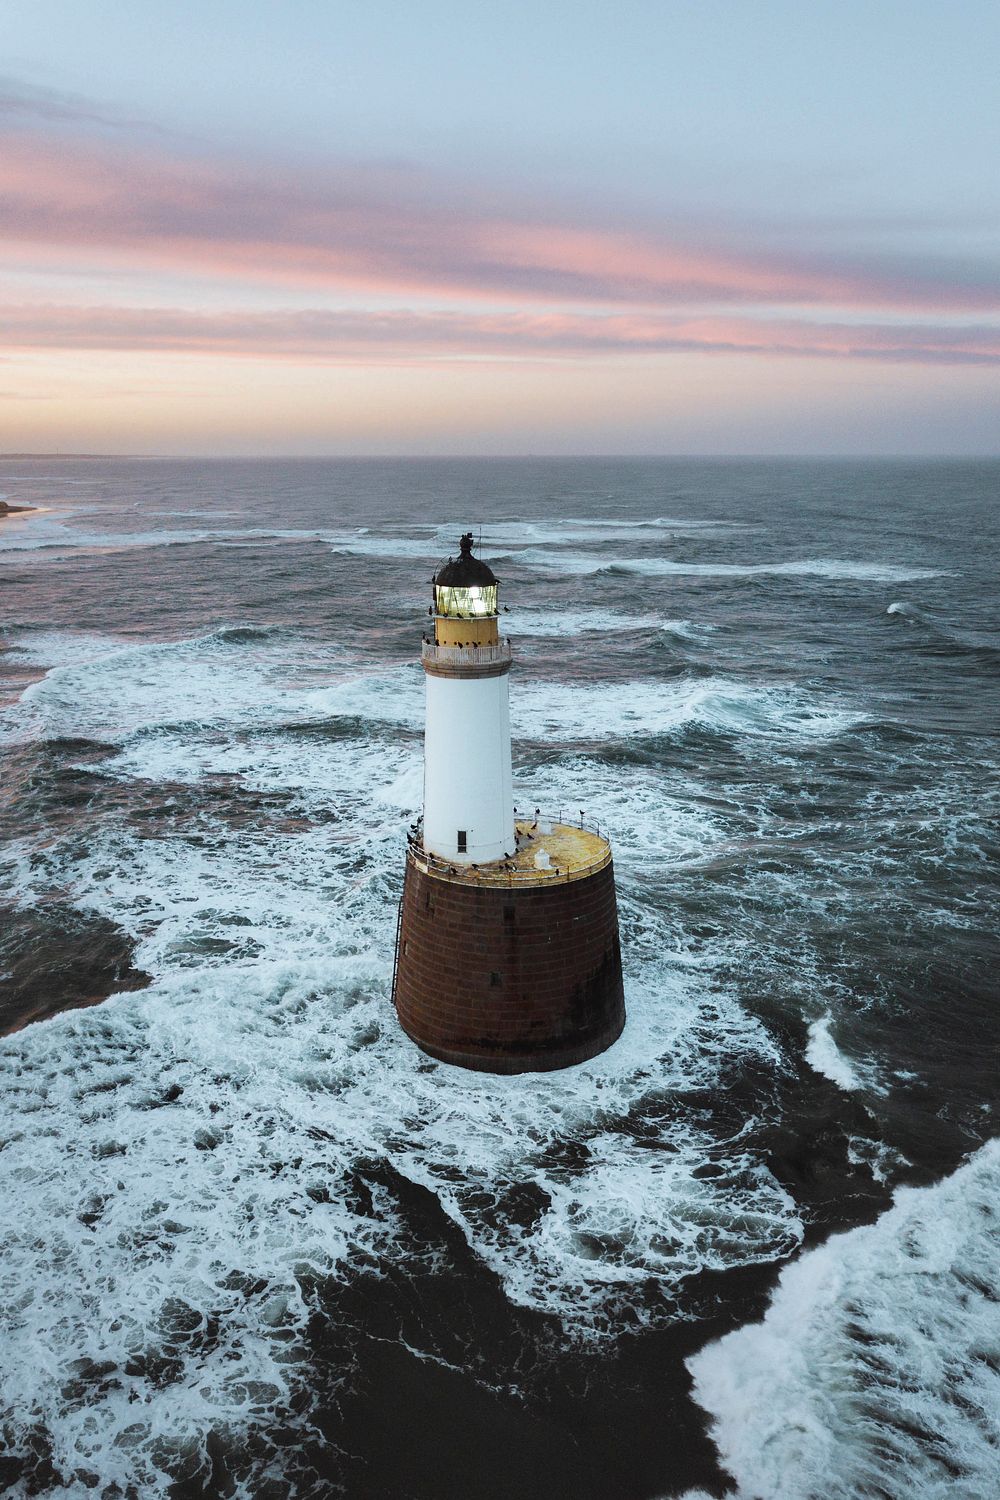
[0,353,996,456]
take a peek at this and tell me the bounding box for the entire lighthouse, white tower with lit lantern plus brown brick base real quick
[393,533,625,1073]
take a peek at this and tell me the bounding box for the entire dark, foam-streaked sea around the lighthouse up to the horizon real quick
[0,459,1000,1500]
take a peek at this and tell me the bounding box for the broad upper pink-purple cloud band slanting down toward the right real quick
[0,122,1000,312]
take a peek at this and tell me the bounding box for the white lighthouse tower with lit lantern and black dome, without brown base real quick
[423,531,516,864]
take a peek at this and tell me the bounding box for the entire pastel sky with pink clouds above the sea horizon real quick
[0,0,1000,456]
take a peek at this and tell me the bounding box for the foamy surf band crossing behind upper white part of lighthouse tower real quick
[3,630,862,762]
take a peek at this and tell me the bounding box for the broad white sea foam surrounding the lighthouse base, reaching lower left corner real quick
[0,621,802,1494]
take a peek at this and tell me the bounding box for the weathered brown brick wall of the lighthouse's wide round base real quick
[396,860,625,1073]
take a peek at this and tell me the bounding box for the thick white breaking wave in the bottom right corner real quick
[688,1142,1000,1500]
